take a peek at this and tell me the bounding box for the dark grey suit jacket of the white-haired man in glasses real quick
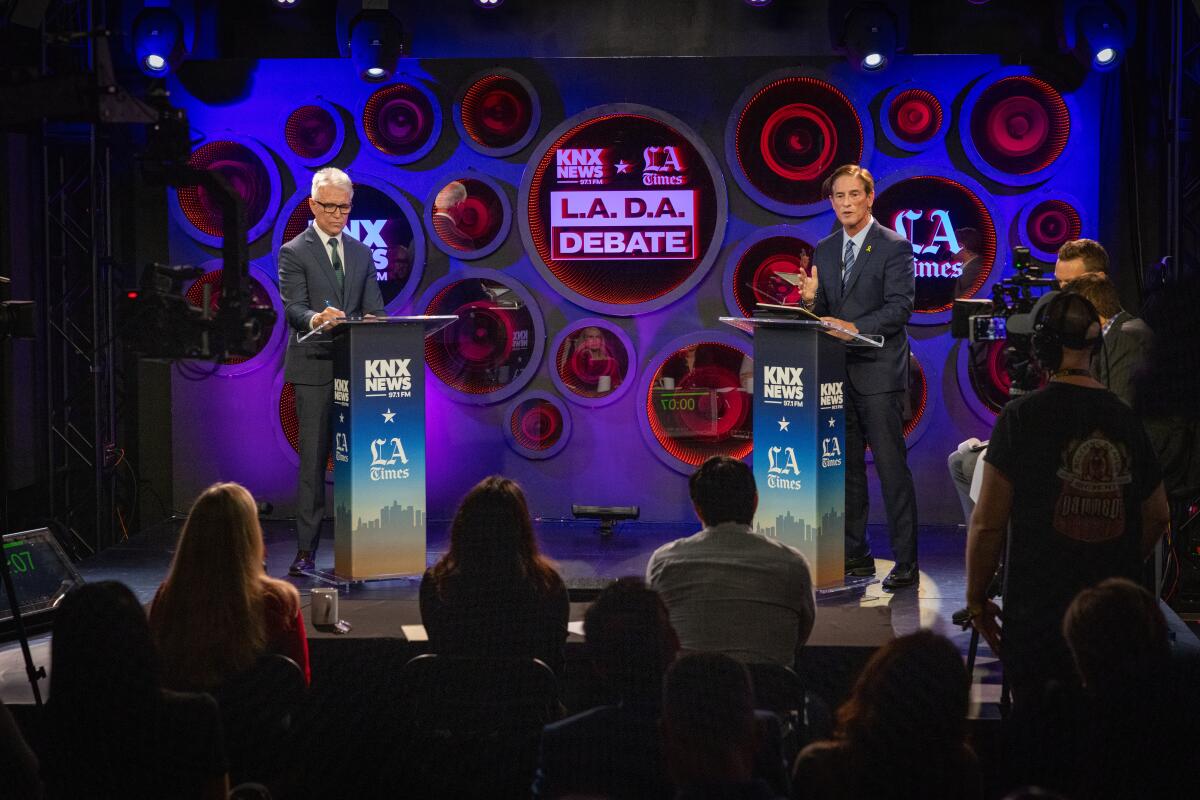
[280,225,383,385]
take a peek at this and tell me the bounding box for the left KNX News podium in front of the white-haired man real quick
[323,315,458,583]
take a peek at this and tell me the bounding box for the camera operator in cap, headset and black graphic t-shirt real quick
[966,291,1168,711]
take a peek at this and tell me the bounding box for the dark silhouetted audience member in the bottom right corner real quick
[1058,578,1200,800]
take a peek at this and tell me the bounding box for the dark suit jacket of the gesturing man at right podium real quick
[812,219,917,395]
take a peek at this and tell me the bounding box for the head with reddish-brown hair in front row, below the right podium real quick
[836,630,971,758]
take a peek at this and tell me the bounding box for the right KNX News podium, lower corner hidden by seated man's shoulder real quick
[721,317,883,589]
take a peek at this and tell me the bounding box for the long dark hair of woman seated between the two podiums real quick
[433,475,552,587]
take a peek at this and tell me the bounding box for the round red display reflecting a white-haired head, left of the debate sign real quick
[425,175,512,259]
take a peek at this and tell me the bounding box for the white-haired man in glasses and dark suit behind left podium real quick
[278,167,383,575]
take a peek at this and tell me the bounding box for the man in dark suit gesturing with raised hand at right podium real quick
[802,164,919,590]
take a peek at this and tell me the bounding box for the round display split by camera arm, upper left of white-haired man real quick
[168,137,281,247]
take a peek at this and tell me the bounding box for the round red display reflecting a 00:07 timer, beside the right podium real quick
[638,332,754,473]
